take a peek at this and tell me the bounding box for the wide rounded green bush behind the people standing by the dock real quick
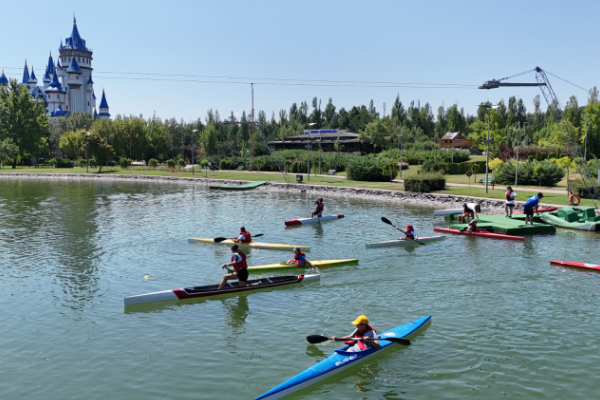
[496,161,565,186]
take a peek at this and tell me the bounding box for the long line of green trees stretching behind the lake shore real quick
[0,80,600,167]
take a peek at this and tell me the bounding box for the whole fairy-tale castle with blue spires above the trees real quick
[0,18,110,119]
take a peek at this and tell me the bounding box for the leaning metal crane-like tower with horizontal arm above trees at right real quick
[479,67,600,200]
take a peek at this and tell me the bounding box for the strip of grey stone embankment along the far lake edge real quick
[0,172,522,213]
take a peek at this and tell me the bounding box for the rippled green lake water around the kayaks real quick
[0,180,600,400]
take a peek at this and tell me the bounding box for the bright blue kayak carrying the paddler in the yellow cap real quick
[255,316,431,400]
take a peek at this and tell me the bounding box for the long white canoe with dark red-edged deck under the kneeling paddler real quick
[125,274,321,307]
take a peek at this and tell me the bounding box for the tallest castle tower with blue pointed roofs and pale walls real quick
[57,18,93,114]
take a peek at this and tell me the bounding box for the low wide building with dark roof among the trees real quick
[267,129,362,152]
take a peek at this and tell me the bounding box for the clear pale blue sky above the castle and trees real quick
[0,0,600,121]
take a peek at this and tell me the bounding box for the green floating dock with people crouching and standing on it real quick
[446,214,556,236]
